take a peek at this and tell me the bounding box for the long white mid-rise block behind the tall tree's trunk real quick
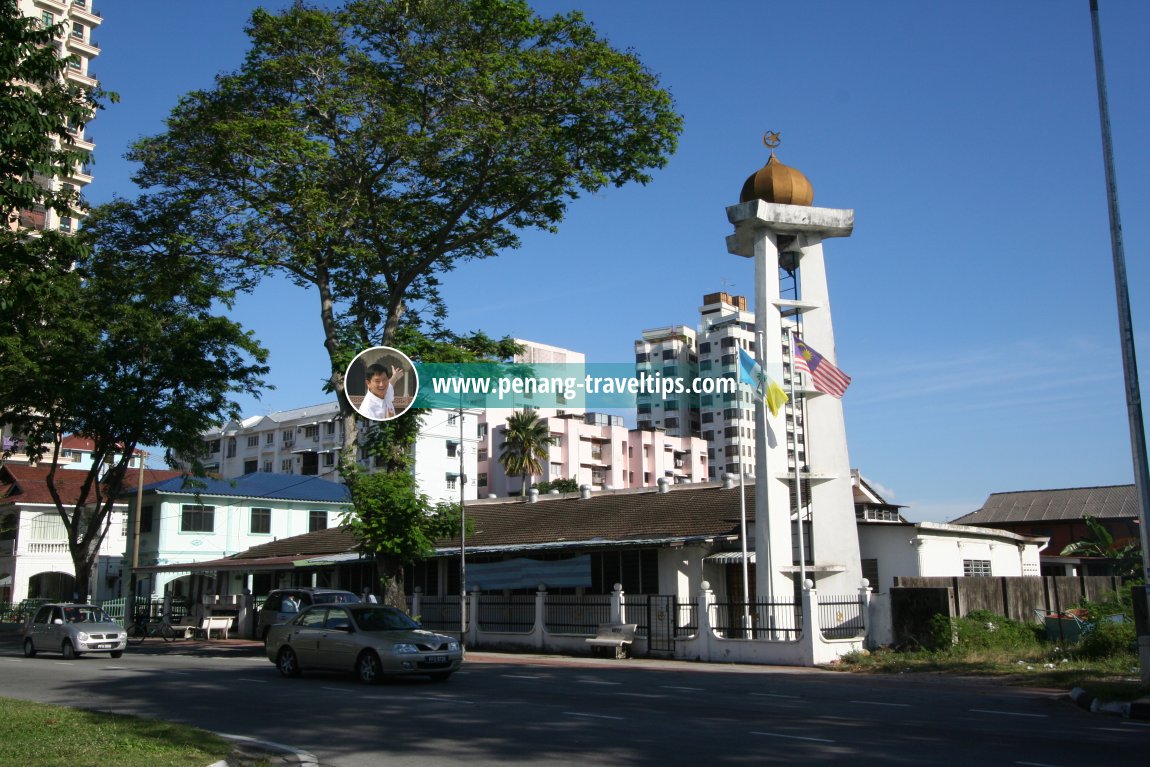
[190,402,480,503]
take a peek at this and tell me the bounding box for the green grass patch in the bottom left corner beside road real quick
[0,698,231,767]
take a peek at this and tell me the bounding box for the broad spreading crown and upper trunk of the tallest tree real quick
[101,0,682,455]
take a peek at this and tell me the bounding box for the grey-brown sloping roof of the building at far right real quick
[952,485,1139,524]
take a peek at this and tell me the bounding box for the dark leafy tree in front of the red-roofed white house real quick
[0,225,267,596]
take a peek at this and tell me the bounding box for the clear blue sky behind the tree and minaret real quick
[87,0,1150,521]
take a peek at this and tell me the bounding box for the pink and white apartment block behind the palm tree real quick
[477,409,707,497]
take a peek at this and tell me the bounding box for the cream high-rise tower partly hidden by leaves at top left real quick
[18,0,104,232]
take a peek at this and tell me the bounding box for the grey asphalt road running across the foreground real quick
[0,642,1150,767]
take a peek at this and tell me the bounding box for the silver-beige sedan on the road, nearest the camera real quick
[265,603,463,684]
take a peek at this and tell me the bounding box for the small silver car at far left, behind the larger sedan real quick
[24,603,128,660]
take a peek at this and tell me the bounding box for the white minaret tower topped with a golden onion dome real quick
[727,133,863,600]
